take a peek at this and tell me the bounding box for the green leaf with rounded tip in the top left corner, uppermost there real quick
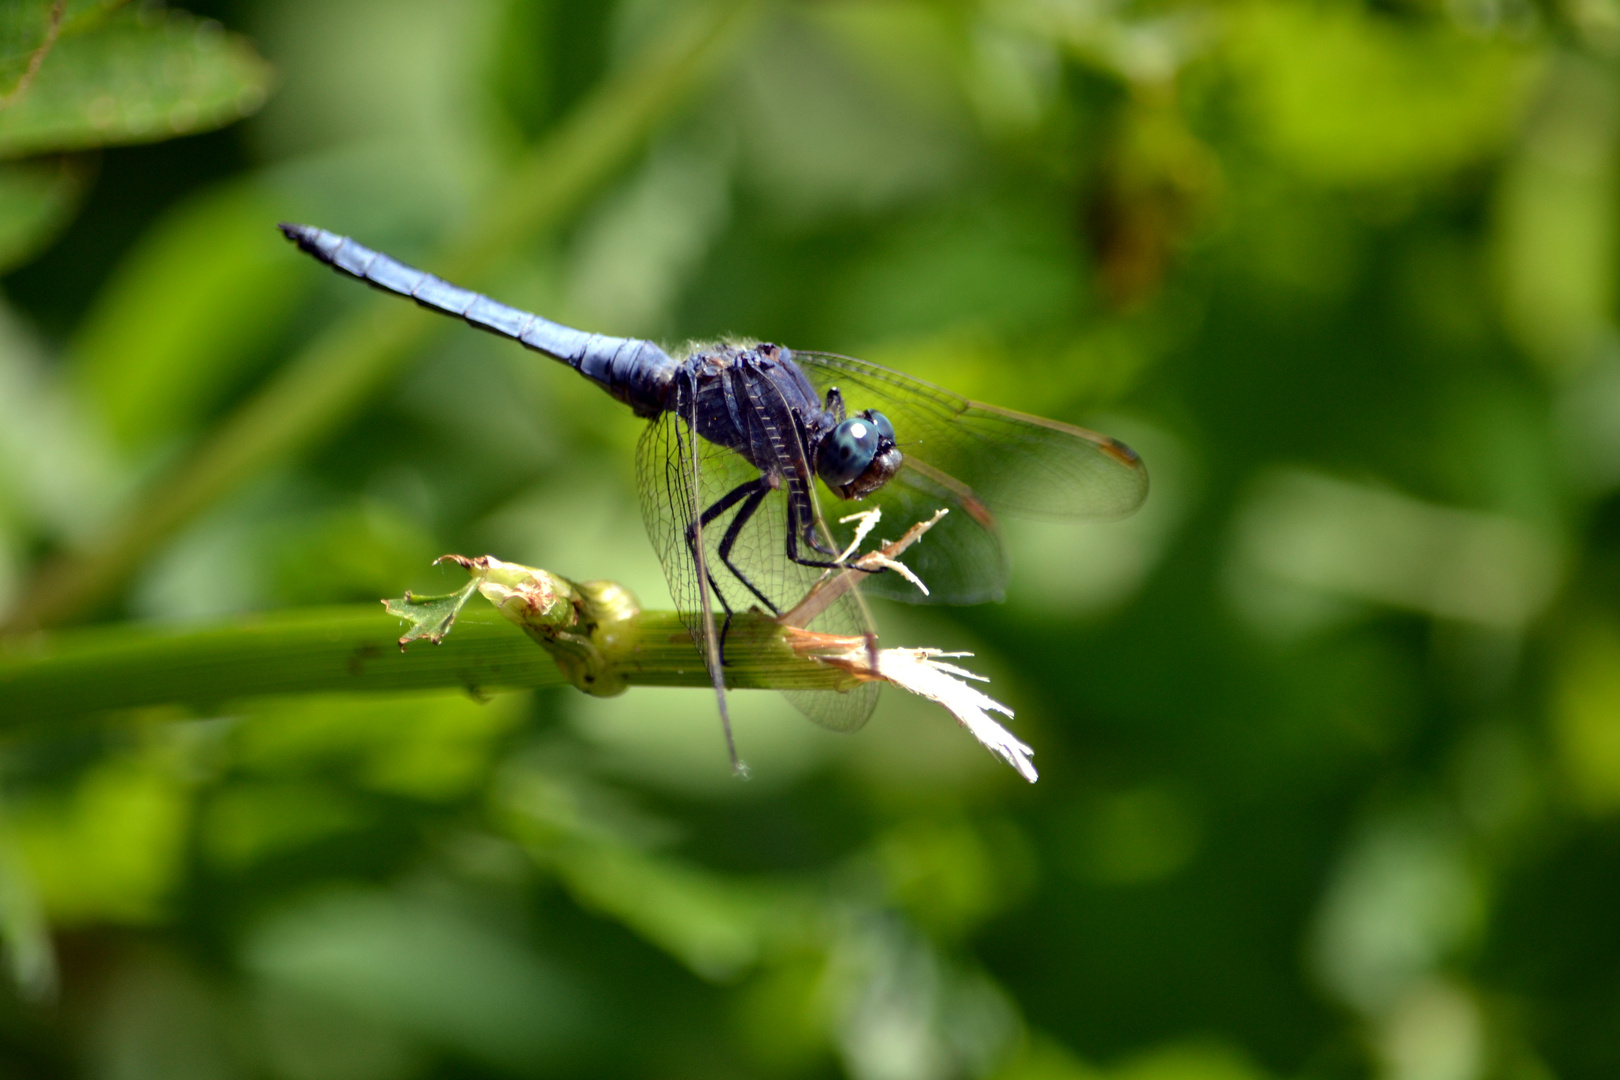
[0,10,271,157]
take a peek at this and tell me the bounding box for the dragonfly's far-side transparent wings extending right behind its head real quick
[792,351,1147,604]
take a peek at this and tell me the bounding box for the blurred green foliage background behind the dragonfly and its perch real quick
[0,0,1620,1080]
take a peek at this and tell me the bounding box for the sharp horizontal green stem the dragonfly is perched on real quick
[0,602,841,730]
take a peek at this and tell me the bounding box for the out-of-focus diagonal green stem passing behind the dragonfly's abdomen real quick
[3,0,760,631]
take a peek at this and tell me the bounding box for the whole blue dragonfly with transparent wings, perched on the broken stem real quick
[280,223,1147,772]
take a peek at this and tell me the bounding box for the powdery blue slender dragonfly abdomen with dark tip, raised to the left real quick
[280,222,676,416]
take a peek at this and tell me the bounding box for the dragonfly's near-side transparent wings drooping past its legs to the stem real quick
[637,382,878,732]
